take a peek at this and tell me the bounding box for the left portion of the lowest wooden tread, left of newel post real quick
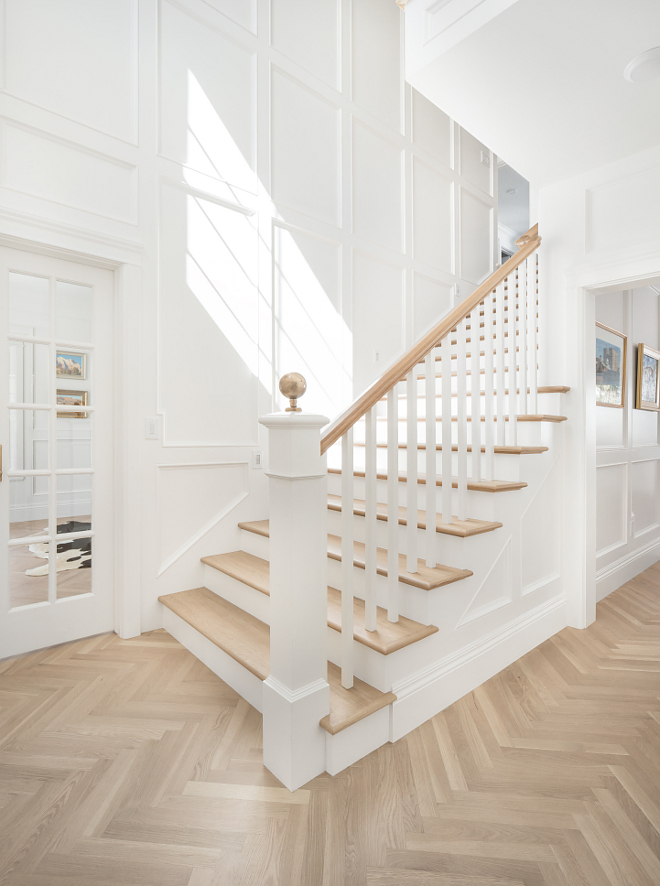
[158,588,270,680]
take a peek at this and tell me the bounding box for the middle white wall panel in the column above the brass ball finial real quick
[271,68,341,225]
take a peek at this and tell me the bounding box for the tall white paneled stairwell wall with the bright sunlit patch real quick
[0,0,497,629]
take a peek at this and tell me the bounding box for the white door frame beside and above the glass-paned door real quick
[0,234,142,639]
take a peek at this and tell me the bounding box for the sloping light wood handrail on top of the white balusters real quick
[321,225,541,454]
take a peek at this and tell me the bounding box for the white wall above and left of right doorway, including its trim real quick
[534,147,660,627]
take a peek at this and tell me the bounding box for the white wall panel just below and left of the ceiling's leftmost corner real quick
[353,120,403,252]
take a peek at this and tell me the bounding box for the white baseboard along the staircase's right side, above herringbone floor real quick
[390,595,568,741]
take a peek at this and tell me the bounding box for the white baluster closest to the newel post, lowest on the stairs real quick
[341,428,354,689]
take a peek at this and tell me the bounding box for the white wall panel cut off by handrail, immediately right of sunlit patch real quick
[353,252,405,394]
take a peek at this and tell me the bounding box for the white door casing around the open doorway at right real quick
[564,255,660,628]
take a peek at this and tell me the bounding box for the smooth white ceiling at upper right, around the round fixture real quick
[408,0,660,185]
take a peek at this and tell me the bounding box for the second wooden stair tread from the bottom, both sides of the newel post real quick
[202,552,438,655]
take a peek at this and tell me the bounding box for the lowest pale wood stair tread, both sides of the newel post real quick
[158,588,396,735]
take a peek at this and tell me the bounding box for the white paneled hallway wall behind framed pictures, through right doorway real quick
[596,286,660,599]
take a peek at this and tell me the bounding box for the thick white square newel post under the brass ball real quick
[260,401,330,791]
